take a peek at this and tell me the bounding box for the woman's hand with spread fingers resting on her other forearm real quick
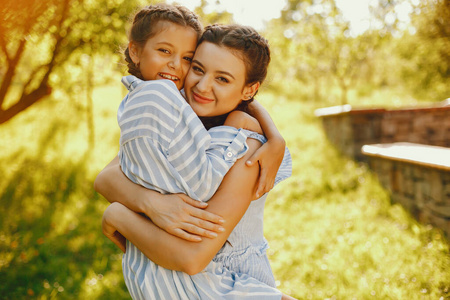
[144,194,224,242]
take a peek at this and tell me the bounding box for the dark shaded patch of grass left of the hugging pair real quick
[0,123,129,299]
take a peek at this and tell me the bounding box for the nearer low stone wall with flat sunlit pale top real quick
[361,143,450,237]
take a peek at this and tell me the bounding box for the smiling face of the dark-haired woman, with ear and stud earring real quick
[184,42,259,117]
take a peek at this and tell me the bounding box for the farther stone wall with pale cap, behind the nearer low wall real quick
[316,100,450,161]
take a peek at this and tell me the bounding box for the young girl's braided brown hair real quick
[124,3,203,80]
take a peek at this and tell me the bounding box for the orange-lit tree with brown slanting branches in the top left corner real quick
[0,0,144,124]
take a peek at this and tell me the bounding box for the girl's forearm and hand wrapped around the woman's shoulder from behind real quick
[247,101,286,198]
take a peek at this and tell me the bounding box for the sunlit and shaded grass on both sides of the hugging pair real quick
[0,81,450,299]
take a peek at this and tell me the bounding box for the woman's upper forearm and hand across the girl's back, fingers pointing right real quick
[94,157,227,242]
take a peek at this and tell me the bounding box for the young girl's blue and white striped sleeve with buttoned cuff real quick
[168,106,248,201]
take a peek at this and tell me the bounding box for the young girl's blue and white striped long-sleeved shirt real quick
[117,75,248,201]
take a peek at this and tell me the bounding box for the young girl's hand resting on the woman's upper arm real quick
[246,138,286,199]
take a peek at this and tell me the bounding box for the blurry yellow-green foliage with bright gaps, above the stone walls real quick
[265,0,450,105]
